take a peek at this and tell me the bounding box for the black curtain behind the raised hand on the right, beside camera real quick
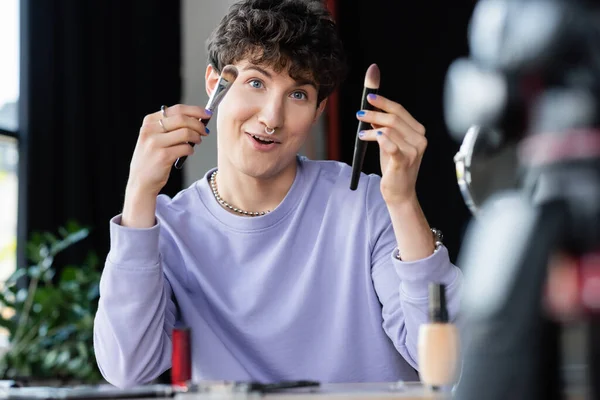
[337,0,475,261]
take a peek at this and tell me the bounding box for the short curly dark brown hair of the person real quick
[207,0,347,103]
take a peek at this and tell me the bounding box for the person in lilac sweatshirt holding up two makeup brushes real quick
[94,0,462,387]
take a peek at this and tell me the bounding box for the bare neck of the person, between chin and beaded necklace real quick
[216,162,297,213]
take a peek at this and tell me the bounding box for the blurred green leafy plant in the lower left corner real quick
[0,222,101,383]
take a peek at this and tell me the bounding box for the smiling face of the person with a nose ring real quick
[206,61,325,179]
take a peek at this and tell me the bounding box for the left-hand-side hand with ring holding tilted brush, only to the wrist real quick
[127,104,210,196]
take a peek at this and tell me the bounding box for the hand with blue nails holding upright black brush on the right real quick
[356,94,427,206]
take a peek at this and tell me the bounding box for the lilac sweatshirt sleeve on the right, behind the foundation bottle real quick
[367,176,462,371]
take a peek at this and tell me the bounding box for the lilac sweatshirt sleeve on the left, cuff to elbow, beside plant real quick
[94,215,176,388]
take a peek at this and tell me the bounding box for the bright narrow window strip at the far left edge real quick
[0,0,20,282]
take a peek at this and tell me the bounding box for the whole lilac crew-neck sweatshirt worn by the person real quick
[94,158,462,387]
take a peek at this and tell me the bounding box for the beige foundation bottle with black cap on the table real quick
[418,283,460,390]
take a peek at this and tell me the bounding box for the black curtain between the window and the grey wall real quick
[18,0,182,265]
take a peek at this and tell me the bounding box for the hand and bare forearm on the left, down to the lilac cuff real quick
[121,104,210,228]
